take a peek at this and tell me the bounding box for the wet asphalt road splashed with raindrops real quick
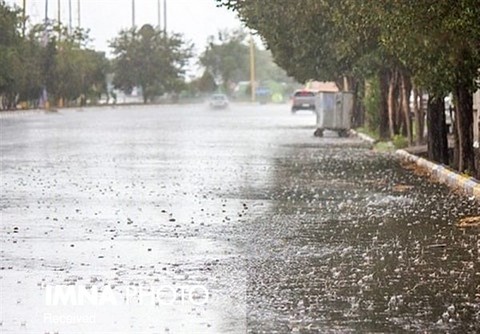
[0,105,480,333]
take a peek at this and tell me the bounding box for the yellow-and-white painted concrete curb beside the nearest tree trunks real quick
[395,150,480,200]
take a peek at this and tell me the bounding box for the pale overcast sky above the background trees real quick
[7,0,241,53]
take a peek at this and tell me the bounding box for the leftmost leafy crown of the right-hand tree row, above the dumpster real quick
[217,0,377,126]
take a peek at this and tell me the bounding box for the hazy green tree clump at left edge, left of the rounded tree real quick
[0,1,109,109]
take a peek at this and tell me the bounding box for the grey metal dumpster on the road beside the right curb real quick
[315,92,353,137]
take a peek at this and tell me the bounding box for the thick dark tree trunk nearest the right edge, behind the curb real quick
[455,84,476,175]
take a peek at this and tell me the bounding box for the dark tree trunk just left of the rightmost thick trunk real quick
[427,96,448,165]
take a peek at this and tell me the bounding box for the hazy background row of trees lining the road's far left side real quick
[0,0,291,109]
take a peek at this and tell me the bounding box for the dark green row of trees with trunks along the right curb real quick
[217,0,480,175]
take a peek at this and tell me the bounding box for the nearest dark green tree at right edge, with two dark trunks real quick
[368,0,480,174]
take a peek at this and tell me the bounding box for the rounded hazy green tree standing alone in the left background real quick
[110,24,193,103]
